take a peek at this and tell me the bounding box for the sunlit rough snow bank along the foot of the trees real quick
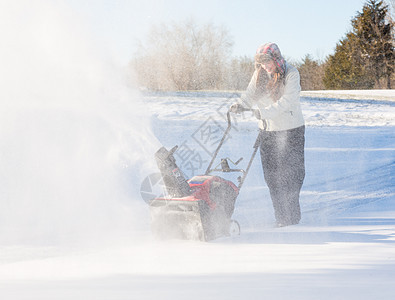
[145,90,395,127]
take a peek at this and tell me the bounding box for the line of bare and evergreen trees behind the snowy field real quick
[130,0,395,90]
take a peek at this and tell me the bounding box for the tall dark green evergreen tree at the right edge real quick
[323,0,395,89]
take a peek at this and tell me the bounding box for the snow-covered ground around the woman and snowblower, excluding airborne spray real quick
[0,91,395,300]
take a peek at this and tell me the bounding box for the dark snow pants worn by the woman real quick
[260,126,305,226]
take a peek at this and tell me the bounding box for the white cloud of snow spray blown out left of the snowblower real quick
[0,1,157,244]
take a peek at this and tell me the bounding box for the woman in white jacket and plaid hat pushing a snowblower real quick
[230,43,305,226]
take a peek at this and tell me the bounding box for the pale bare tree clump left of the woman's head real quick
[132,20,233,90]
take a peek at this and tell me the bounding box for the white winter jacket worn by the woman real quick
[241,63,304,131]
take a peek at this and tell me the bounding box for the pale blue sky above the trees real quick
[67,0,366,63]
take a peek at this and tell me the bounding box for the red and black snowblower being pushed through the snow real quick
[149,112,259,241]
